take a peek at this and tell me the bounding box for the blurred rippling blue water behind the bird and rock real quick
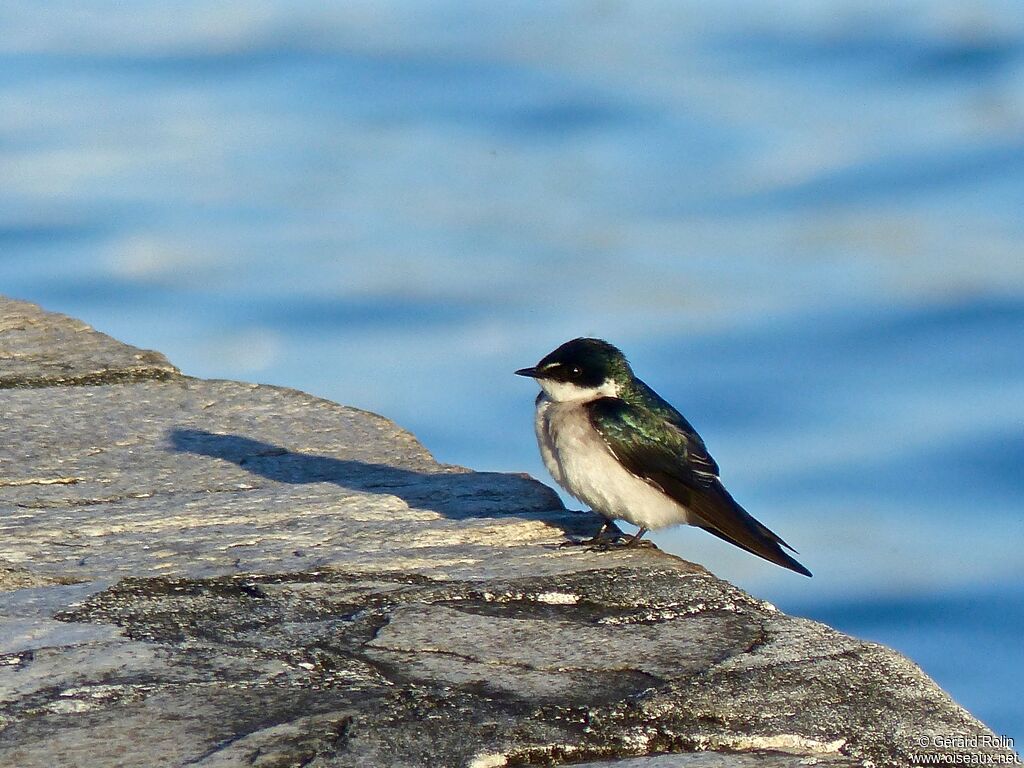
[0,0,1024,746]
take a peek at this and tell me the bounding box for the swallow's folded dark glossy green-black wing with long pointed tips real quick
[586,397,811,575]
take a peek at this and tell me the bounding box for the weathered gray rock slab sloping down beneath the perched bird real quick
[0,300,1011,768]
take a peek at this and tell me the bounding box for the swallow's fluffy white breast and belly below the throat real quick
[535,395,688,528]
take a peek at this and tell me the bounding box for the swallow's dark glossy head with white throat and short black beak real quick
[516,339,633,402]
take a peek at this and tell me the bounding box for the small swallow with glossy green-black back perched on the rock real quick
[515,338,811,577]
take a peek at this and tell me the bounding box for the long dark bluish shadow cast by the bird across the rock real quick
[169,429,577,532]
